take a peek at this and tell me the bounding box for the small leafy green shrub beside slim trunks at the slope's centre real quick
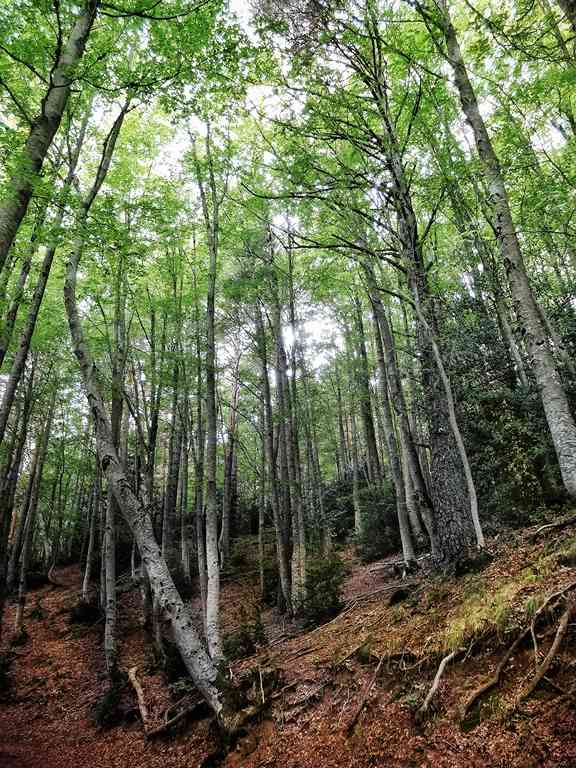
[302,555,346,626]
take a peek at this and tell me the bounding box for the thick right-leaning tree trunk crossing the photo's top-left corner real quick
[0,0,100,270]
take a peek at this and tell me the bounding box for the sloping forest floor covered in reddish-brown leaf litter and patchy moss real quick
[0,516,576,768]
